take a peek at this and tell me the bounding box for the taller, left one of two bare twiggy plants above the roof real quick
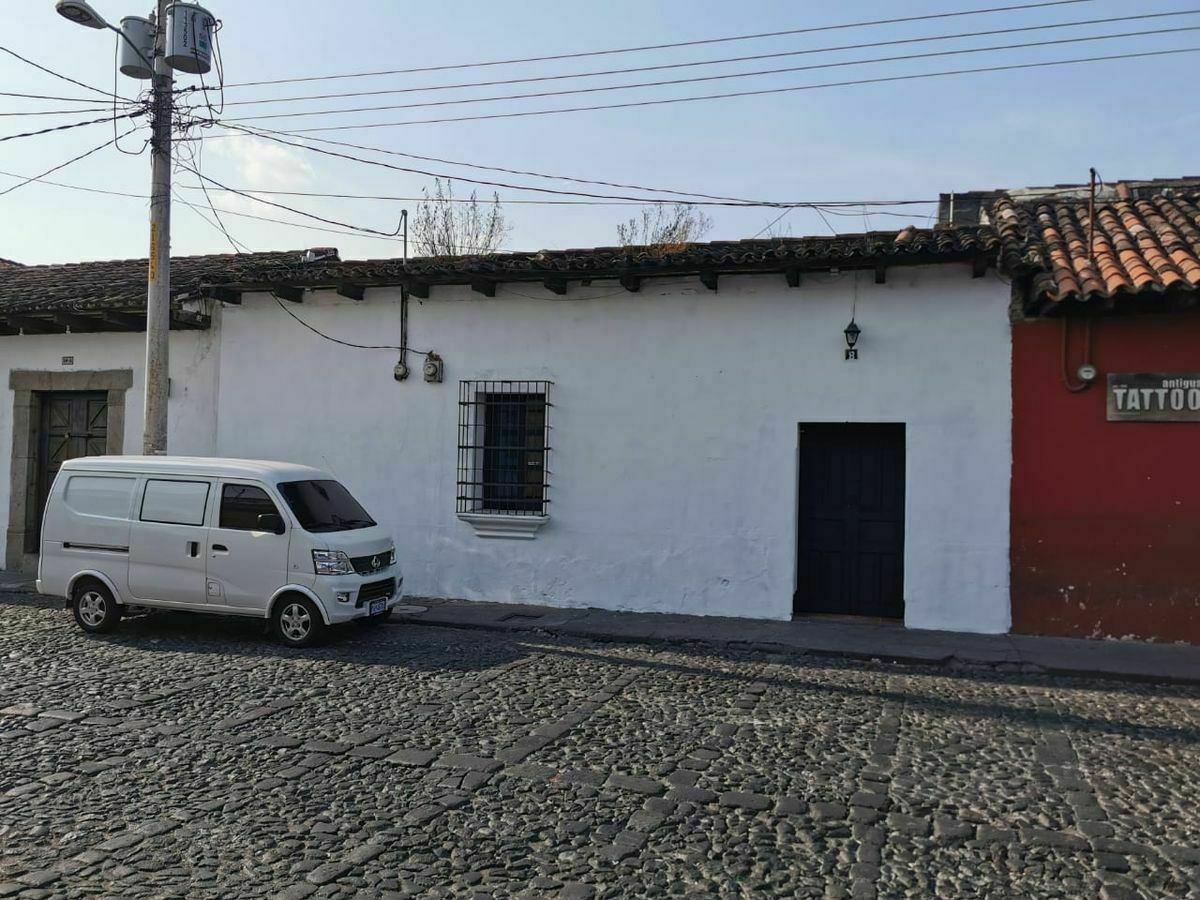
[413,179,511,257]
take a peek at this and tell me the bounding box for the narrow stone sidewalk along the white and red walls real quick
[394,599,1200,683]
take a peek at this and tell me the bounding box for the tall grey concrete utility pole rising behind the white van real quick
[142,0,175,456]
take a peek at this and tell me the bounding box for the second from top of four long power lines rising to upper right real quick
[211,10,1200,112]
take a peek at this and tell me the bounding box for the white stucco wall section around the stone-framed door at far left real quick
[0,330,220,560]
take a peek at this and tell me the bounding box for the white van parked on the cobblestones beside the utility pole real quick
[37,456,403,647]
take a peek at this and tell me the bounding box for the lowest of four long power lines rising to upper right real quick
[226,47,1200,134]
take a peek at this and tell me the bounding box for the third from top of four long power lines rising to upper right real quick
[224,25,1200,122]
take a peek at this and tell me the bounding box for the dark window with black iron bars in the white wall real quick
[458,382,552,516]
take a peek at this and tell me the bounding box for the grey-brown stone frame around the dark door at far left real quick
[5,368,133,572]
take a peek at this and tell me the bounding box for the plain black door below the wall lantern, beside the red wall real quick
[793,424,905,618]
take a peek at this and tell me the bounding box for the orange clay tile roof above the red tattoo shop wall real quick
[991,180,1200,310]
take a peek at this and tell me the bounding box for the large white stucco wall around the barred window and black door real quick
[211,265,1012,632]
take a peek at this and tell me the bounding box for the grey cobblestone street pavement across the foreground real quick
[0,594,1200,898]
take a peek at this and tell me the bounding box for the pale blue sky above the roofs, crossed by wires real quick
[0,0,1200,264]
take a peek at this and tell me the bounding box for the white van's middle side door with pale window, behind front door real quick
[130,475,216,606]
